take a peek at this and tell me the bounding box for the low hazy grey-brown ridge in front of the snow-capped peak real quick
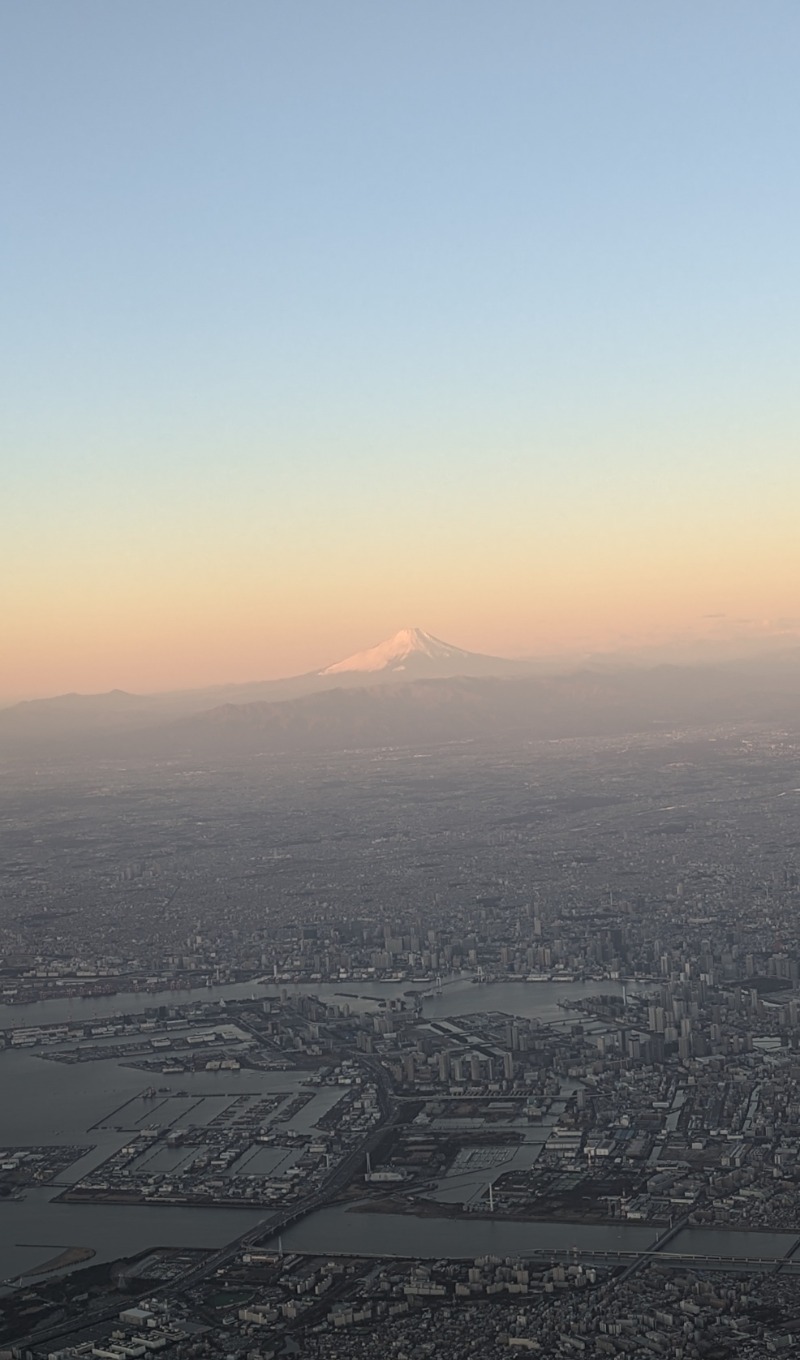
[138,666,800,755]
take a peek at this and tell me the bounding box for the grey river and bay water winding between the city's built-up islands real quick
[0,978,796,1281]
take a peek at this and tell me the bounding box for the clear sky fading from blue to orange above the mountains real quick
[0,0,800,702]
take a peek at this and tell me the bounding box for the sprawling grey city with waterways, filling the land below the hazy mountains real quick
[0,726,800,1360]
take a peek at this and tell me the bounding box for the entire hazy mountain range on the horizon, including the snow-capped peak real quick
[0,628,800,758]
